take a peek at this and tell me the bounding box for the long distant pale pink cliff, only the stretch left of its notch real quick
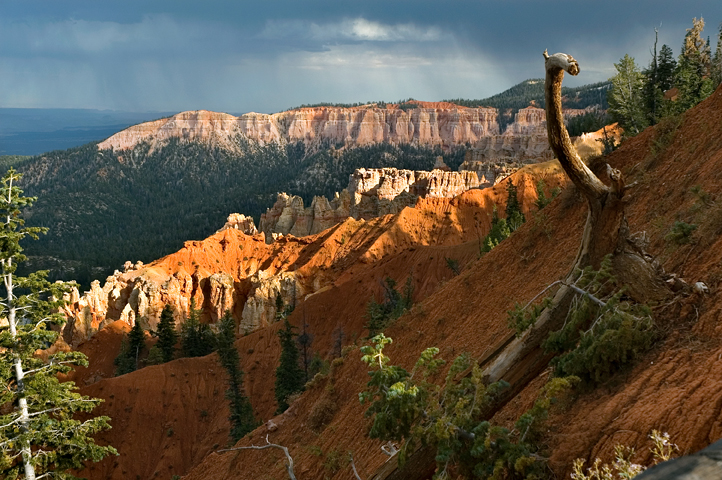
[98,103,499,150]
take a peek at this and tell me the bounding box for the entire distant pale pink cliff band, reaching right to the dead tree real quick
[98,101,586,156]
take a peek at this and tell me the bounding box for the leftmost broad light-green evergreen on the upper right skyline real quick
[607,55,648,136]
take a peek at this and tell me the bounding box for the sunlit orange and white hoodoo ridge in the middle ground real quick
[63,165,560,346]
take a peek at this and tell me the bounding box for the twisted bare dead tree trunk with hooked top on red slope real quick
[372,50,669,480]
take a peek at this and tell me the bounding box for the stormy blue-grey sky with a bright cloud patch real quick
[0,0,722,114]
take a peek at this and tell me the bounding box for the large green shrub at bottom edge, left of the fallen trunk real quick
[359,334,578,479]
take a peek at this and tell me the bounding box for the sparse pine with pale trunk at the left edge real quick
[0,169,117,480]
